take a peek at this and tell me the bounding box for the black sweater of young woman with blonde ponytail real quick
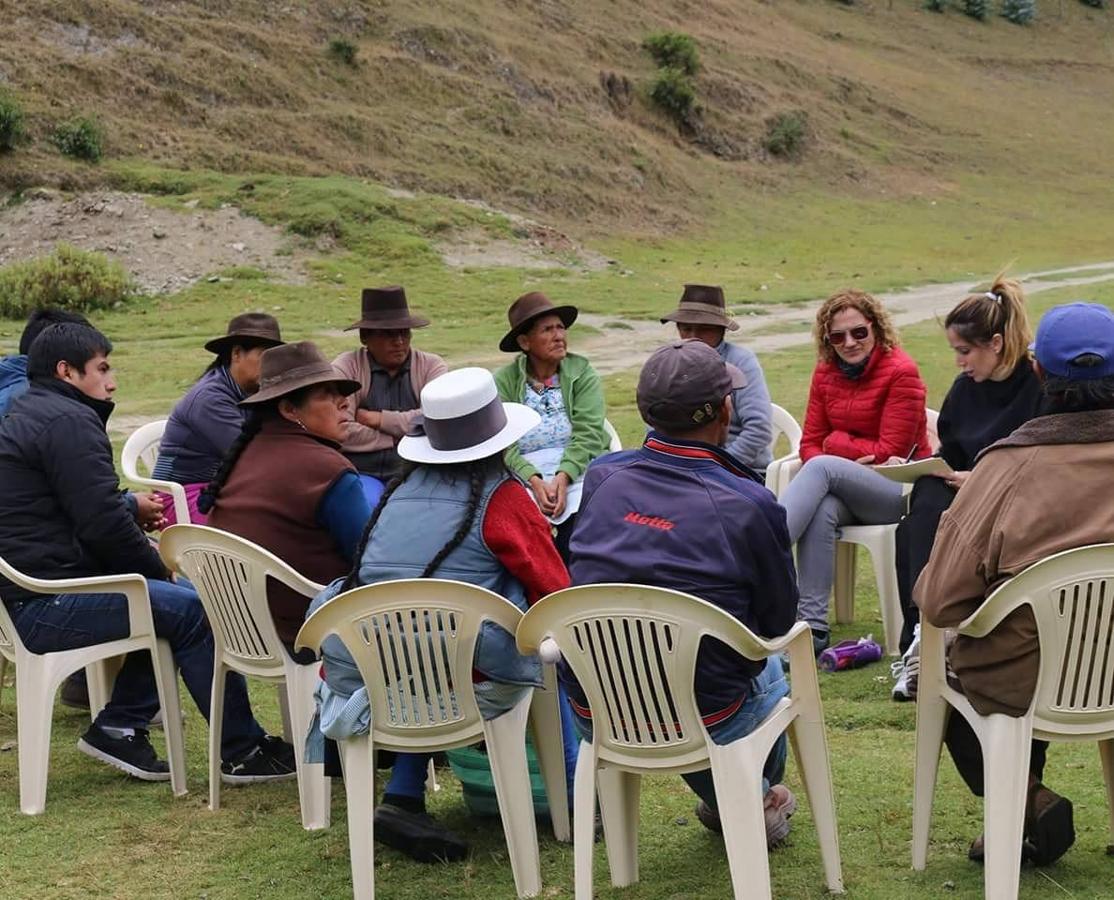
[937,360,1042,471]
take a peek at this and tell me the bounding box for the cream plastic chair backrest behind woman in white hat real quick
[295,578,522,750]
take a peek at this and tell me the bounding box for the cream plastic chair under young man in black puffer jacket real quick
[0,559,186,815]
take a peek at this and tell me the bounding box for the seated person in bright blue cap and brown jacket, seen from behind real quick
[913,303,1114,865]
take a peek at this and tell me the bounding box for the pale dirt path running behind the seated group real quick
[574,261,1114,374]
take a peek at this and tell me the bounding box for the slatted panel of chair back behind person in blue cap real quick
[1054,578,1114,711]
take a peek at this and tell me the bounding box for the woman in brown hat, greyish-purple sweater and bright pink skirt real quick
[152,313,283,525]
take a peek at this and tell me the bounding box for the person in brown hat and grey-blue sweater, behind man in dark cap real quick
[662,284,773,476]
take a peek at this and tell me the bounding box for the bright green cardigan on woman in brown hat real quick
[495,353,609,481]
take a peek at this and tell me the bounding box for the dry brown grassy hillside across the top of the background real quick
[0,0,1114,234]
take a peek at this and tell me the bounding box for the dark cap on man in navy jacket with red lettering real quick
[637,340,746,432]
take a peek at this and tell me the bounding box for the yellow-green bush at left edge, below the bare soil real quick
[0,244,136,319]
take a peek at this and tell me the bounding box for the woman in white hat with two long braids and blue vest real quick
[307,369,575,862]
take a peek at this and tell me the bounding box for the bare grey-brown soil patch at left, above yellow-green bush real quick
[0,190,309,293]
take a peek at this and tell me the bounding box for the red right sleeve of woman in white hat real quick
[483,479,569,606]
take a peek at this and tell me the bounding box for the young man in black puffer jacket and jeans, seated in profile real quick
[0,323,294,783]
